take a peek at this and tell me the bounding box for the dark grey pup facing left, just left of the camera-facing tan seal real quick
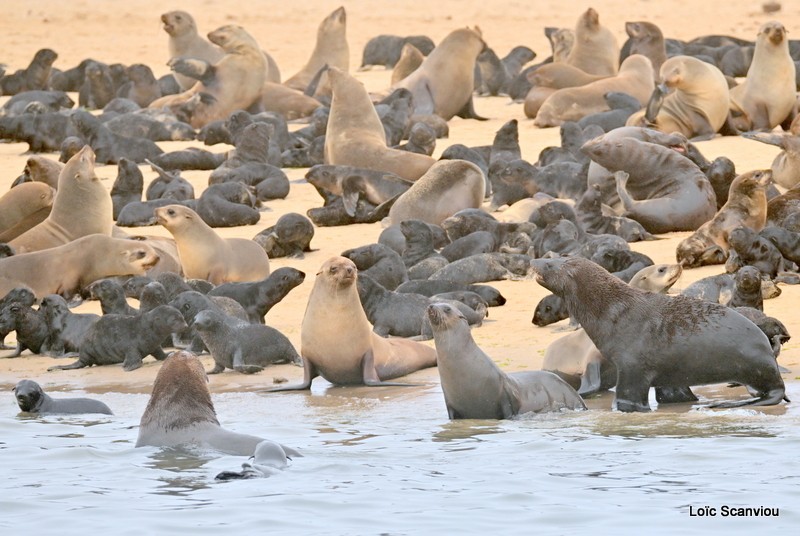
[192,310,301,374]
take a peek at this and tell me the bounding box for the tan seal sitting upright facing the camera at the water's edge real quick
[274,257,436,391]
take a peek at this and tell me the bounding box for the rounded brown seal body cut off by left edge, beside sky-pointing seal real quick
[0,182,55,242]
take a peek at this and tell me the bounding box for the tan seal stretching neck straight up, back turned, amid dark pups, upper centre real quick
[325,68,436,181]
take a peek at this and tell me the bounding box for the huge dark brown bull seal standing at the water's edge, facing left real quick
[532,257,786,412]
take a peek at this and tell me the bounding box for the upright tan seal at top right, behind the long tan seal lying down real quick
[566,8,619,76]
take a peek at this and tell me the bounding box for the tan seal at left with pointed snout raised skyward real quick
[9,145,114,253]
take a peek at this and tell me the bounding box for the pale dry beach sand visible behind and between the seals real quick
[0,0,800,398]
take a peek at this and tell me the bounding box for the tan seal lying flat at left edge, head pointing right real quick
[0,234,158,299]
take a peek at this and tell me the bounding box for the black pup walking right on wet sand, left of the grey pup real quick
[47,305,187,372]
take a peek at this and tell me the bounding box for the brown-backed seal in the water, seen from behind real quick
[136,351,302,456]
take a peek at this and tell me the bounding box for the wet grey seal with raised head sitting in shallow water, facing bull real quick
[427,303,586,419]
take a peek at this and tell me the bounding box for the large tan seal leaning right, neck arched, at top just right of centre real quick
[395,28,486,120]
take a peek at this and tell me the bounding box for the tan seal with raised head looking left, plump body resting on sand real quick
[154,205,269,285]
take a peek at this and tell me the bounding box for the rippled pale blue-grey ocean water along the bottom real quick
[0,380,800,535]
